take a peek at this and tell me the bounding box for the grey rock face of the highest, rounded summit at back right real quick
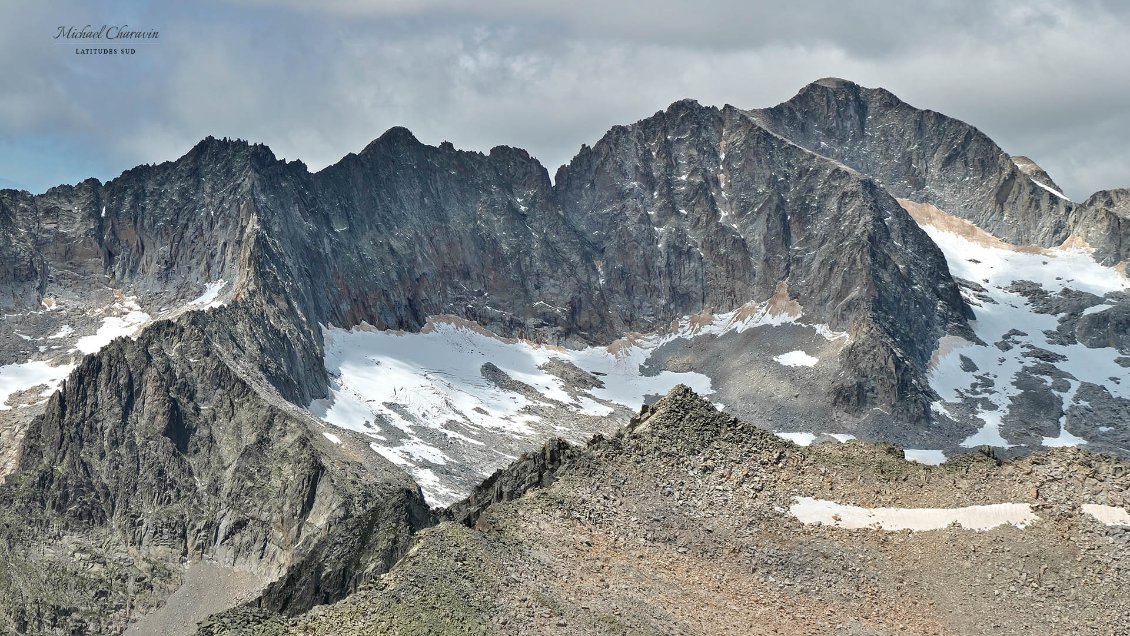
[751,78,1072,246]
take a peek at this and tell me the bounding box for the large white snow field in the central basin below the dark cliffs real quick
[308,302,846,502]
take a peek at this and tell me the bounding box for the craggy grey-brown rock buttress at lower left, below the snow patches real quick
[5,307,432,632]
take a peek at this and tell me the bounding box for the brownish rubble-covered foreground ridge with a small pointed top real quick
[201,386,1130,634]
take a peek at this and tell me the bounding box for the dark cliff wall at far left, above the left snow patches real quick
[0,138,263,311]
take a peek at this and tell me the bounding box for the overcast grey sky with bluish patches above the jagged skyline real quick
[0,0,1130,200]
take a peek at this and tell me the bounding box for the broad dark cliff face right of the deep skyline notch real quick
[556,102,966,417]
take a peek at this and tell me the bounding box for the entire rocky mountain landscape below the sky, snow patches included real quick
[0,78,1130,635]
